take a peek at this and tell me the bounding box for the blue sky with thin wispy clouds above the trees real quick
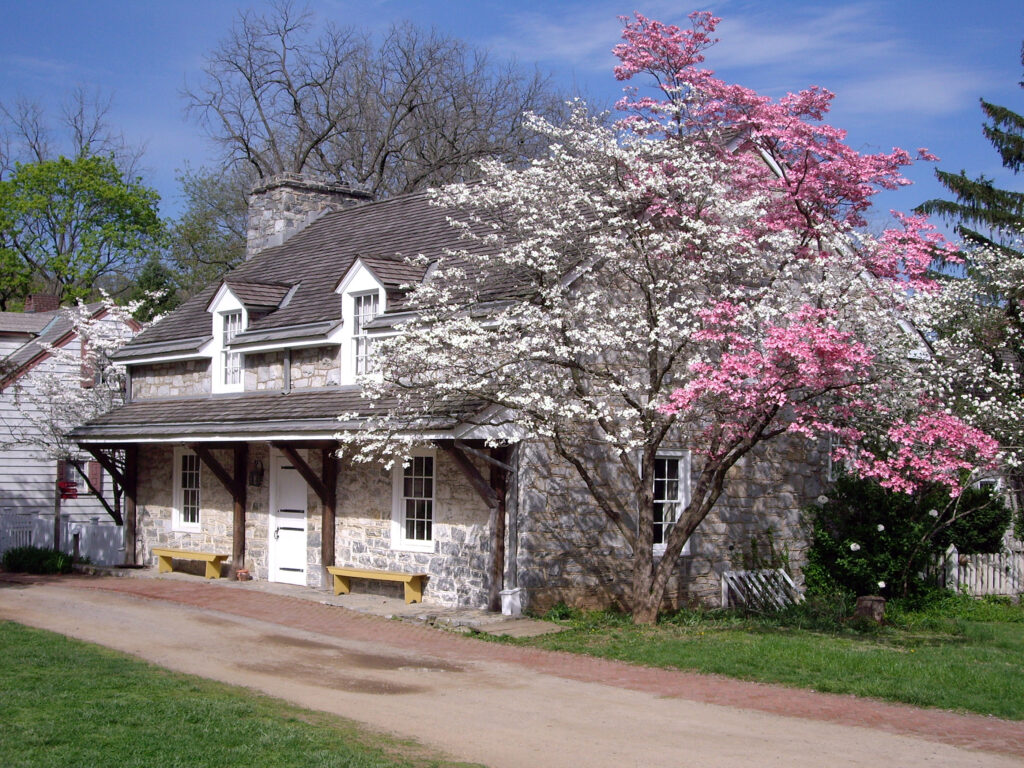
[0,0,1024,233]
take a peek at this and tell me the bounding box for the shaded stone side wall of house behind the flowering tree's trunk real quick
[516,439,824,611]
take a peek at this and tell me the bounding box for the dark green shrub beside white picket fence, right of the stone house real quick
[804,476,1011,596]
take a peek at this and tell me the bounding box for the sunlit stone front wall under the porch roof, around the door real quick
[138,443,489,606]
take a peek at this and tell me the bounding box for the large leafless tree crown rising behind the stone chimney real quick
[184,1,563,196]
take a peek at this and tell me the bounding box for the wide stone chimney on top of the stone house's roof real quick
[246,173,373,259]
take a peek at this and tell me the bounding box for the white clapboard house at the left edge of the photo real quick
[0,294,134,564]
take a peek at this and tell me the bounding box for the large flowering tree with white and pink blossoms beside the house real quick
[341,13,995,623]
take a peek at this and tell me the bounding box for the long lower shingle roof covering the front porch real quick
[72,386,480,442]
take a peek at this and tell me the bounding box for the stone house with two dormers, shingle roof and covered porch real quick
[74,175,824,609]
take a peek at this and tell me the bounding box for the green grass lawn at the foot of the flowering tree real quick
[503,597,1024,720]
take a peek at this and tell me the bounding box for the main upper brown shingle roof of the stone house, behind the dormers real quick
[126,194,503,349]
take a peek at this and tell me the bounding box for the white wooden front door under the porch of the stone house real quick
[268,451,306,586]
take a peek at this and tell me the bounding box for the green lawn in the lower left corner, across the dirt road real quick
[0,622,479,768]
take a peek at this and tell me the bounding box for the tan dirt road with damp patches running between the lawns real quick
[0,580,1024,768]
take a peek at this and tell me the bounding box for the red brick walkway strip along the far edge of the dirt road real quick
[12,574,1024,758]
